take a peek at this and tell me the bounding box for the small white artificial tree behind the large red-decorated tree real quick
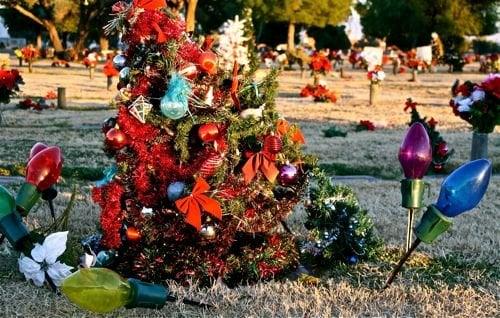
[218,16,249,71]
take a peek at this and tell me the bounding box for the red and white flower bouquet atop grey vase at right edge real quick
[450,73,500,133]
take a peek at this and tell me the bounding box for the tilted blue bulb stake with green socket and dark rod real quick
[384,159,491,289]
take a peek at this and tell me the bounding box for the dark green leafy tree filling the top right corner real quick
[357,0,498,51]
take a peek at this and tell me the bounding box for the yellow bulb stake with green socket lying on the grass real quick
[61,268,210,313]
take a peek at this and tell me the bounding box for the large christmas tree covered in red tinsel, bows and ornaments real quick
[93,0,314,284]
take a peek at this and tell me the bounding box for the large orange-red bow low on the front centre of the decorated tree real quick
[175,178,222,231]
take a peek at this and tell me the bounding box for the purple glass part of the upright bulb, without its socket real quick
[399,123,432,179]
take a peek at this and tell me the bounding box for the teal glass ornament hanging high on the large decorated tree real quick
[160,73,191,120]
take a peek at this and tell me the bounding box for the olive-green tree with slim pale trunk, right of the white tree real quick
[245,0,352,50]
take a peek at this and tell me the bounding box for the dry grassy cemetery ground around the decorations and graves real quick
[0,61,500,317]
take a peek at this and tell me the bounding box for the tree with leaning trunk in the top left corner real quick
[0,0,79,52]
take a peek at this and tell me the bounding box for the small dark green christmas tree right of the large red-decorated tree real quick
[301,169,380,269]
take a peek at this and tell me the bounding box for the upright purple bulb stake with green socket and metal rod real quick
[398,123,432,251]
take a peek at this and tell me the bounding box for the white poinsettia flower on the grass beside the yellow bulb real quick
[18,232,73,287]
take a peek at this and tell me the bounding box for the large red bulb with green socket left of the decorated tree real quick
[16,145,63,216]
